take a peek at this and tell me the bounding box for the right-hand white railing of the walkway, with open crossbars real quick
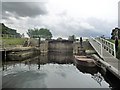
[96,38,116,58]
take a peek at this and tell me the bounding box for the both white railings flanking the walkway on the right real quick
[89,37,116,58]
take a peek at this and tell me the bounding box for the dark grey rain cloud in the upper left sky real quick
[2,2,47,19]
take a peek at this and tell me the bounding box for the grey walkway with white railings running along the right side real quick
[89,37,120,79]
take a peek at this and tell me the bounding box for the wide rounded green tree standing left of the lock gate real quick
[27,28,52,39]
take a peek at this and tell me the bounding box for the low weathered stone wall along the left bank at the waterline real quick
[6,47,39,61]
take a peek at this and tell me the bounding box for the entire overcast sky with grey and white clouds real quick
[2,0,119,38]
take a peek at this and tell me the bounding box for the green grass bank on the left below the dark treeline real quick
[0,38,26,46]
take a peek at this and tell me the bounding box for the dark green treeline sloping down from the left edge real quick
[0,23,21,38]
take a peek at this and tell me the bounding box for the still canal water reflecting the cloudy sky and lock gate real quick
[2,53,118,88]
